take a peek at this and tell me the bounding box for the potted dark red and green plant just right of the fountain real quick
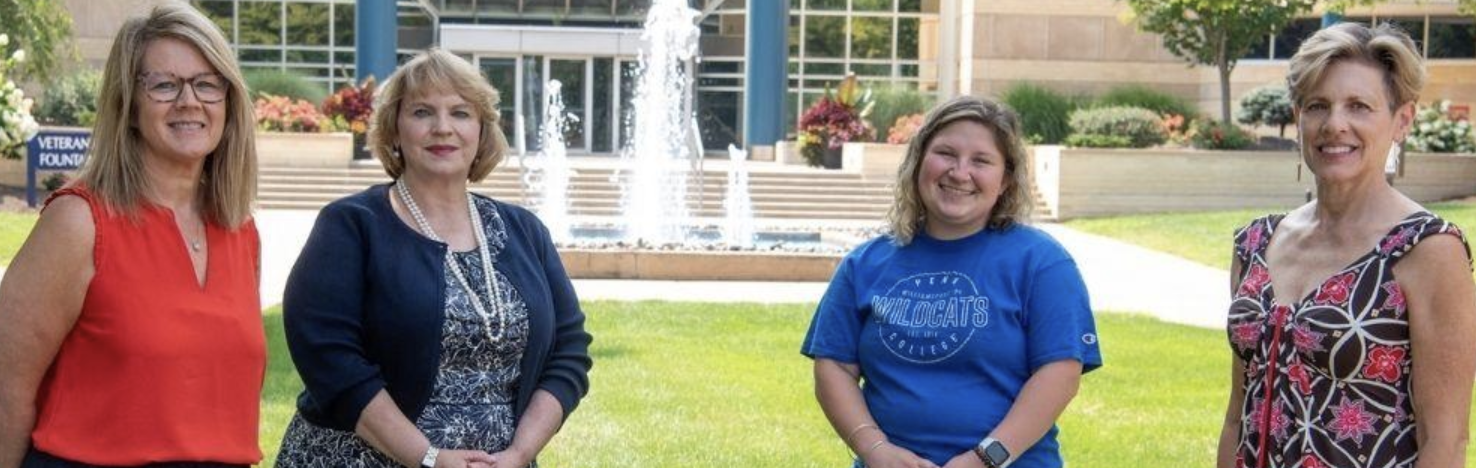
[799,75,874,165]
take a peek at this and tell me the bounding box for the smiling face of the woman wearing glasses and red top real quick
[133,37,227,167]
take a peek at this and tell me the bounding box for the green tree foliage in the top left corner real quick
[0,0,75,78]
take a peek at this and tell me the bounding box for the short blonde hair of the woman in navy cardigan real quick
[369,49,508,182]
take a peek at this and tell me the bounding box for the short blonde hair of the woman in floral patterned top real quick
[1287,22,1424,111]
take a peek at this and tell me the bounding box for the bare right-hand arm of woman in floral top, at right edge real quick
[1395,236,1476,468]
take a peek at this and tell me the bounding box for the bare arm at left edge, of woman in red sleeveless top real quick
[0,196,94,467]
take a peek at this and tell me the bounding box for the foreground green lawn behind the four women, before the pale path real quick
[261,301,1228,468]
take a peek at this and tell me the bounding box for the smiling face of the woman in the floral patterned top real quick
[1297,61,1414,183]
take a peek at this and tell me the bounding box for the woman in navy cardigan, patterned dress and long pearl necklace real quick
[277,50,592,467]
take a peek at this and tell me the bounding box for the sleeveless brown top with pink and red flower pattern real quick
[1227,211,1470,468]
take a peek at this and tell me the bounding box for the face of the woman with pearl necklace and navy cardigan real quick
[397,92,481,182]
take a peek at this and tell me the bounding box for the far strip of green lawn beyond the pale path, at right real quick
[1066,202,1476,270]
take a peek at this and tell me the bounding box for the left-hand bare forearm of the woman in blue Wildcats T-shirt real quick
[815,357,937,468]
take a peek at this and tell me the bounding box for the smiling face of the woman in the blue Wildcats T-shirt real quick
[918,120,1005,239]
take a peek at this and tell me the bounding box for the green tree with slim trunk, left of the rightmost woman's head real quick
[1128,0,1322,123]
